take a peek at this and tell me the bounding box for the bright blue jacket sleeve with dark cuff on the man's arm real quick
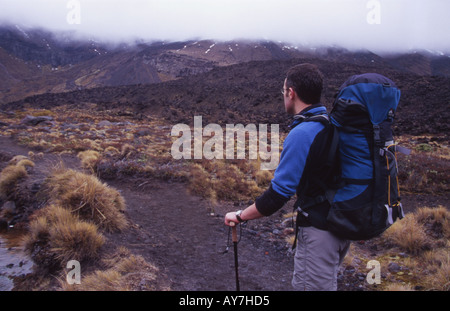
[255,122,323,216]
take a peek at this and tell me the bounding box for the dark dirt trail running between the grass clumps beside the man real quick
[0,136,293,291]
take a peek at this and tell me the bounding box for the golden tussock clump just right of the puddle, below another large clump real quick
[24,205,105,266]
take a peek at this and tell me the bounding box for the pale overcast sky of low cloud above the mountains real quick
[0,0,450,52]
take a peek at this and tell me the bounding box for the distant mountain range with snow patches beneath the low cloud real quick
[0,25,450,103]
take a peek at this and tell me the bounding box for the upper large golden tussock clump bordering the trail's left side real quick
[45,168,128,232]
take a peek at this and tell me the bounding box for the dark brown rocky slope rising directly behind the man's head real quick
[4,58,450,140]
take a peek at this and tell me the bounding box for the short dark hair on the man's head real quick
[286,63,323,105]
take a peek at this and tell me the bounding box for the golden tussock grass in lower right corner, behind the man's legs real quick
[380,206,450,291]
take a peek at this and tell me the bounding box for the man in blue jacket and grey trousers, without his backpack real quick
[225,64,350,291]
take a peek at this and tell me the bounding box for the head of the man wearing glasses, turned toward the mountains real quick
[283,64,323,114]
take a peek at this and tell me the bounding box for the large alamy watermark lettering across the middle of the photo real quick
[171,116,280,170]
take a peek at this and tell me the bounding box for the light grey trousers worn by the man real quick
[292,227,350,291]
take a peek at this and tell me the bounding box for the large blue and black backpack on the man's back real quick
[326,73,409,240]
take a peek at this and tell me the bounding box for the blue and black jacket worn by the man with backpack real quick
[255,104,327,224]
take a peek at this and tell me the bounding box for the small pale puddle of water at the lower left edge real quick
[0,236,33,291]
